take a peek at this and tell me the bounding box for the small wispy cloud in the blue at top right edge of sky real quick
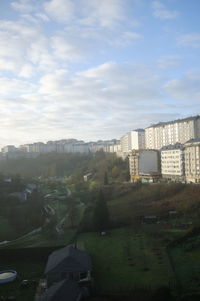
[152,0,179,20]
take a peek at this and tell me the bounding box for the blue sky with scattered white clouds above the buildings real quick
[0,0,200,147]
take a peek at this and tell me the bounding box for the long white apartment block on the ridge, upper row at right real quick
[145,116,200,149]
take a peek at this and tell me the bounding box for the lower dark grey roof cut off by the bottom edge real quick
[44,279,81,301]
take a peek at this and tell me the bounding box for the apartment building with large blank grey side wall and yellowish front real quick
[129,150,160,182]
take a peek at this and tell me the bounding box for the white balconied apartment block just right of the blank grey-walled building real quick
[161,143,185,181]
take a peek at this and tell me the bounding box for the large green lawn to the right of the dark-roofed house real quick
[78,228,175,293]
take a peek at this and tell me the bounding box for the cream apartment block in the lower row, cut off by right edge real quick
[184,139,200,183]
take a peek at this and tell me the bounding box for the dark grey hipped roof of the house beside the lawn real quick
[45,245,92,274]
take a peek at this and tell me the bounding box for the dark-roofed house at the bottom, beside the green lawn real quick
[45,245,92,286]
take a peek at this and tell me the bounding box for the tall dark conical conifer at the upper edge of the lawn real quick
[93,190,110,231]
